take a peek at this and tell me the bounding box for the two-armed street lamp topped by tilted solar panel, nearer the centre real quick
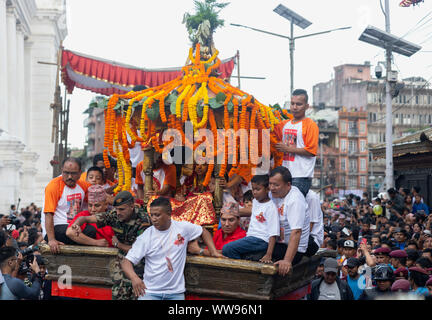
[231,4,351,94]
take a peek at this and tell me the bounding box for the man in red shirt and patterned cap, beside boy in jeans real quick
[188,202,246,256]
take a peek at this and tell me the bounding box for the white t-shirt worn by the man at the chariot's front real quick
[126,220,203,294]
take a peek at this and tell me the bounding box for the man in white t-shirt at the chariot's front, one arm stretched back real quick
[121,197,223,300]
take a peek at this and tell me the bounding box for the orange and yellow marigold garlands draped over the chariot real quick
[103,44,292,193]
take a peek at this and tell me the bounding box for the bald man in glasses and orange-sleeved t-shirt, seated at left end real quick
[41,158,90,254]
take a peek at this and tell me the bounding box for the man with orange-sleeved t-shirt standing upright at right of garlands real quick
[275,89,319,197]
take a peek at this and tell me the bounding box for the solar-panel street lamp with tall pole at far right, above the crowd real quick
[359,0,421,189]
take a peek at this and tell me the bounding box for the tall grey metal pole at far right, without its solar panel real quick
[385,0,394,189]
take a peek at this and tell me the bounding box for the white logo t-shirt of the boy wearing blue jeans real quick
[246,199,280,243]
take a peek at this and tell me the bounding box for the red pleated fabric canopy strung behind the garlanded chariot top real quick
[62,50,236,96]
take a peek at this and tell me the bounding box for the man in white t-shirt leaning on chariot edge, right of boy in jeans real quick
[270,167,310,276]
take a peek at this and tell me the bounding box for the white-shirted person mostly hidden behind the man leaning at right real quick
[306,190,324,256]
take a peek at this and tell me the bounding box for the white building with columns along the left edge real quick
[0,0,67,213]
